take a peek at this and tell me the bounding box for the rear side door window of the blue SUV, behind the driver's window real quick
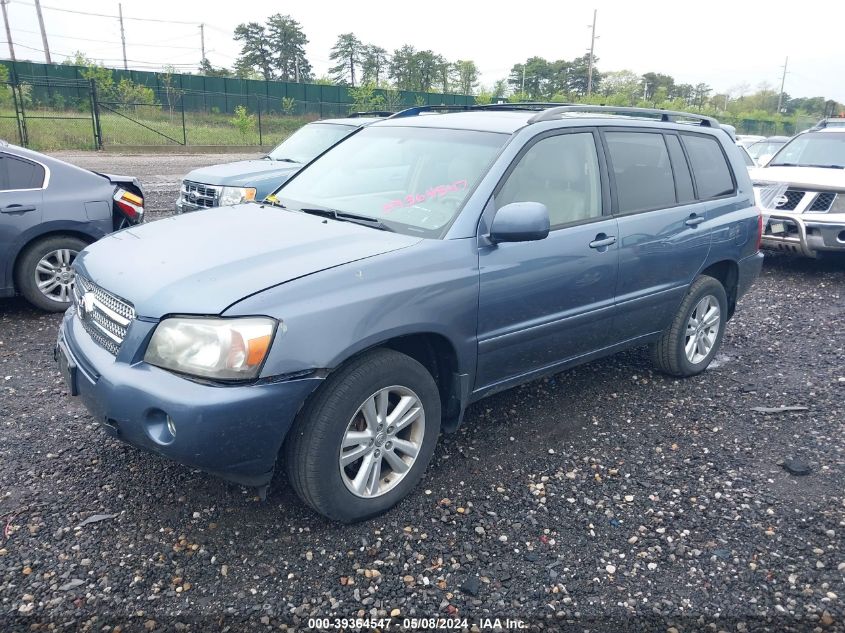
[604,132,677,213]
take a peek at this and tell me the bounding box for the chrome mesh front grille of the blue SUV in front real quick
[73,275,135,356]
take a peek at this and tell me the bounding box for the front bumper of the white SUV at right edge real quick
[763,211,845,257]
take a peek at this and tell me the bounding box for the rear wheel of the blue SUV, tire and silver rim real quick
[651,275,728,376]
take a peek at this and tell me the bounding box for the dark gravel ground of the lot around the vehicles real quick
[0,153,845,633]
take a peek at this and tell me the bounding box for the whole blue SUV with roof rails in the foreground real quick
[56,105,763,522]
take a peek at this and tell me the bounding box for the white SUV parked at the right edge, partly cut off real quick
[750,126,845,257]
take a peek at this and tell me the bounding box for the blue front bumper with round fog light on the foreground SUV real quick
[58,309,321,486]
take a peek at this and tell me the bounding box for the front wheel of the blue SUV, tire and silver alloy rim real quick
[284,349,440,523]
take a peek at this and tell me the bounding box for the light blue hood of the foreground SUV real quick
[74,203,421,318]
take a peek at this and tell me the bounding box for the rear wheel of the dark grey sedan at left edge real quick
[15,235,88,312]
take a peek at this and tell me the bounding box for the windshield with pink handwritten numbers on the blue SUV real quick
[275,126,509,237]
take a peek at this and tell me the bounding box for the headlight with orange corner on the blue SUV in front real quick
[144,317,277,380]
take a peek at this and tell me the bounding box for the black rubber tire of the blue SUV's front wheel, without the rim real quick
[284,349,440,523]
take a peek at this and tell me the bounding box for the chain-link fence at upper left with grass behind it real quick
[0,77,398,151]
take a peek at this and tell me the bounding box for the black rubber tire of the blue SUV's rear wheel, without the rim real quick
[651,275,728,377]
